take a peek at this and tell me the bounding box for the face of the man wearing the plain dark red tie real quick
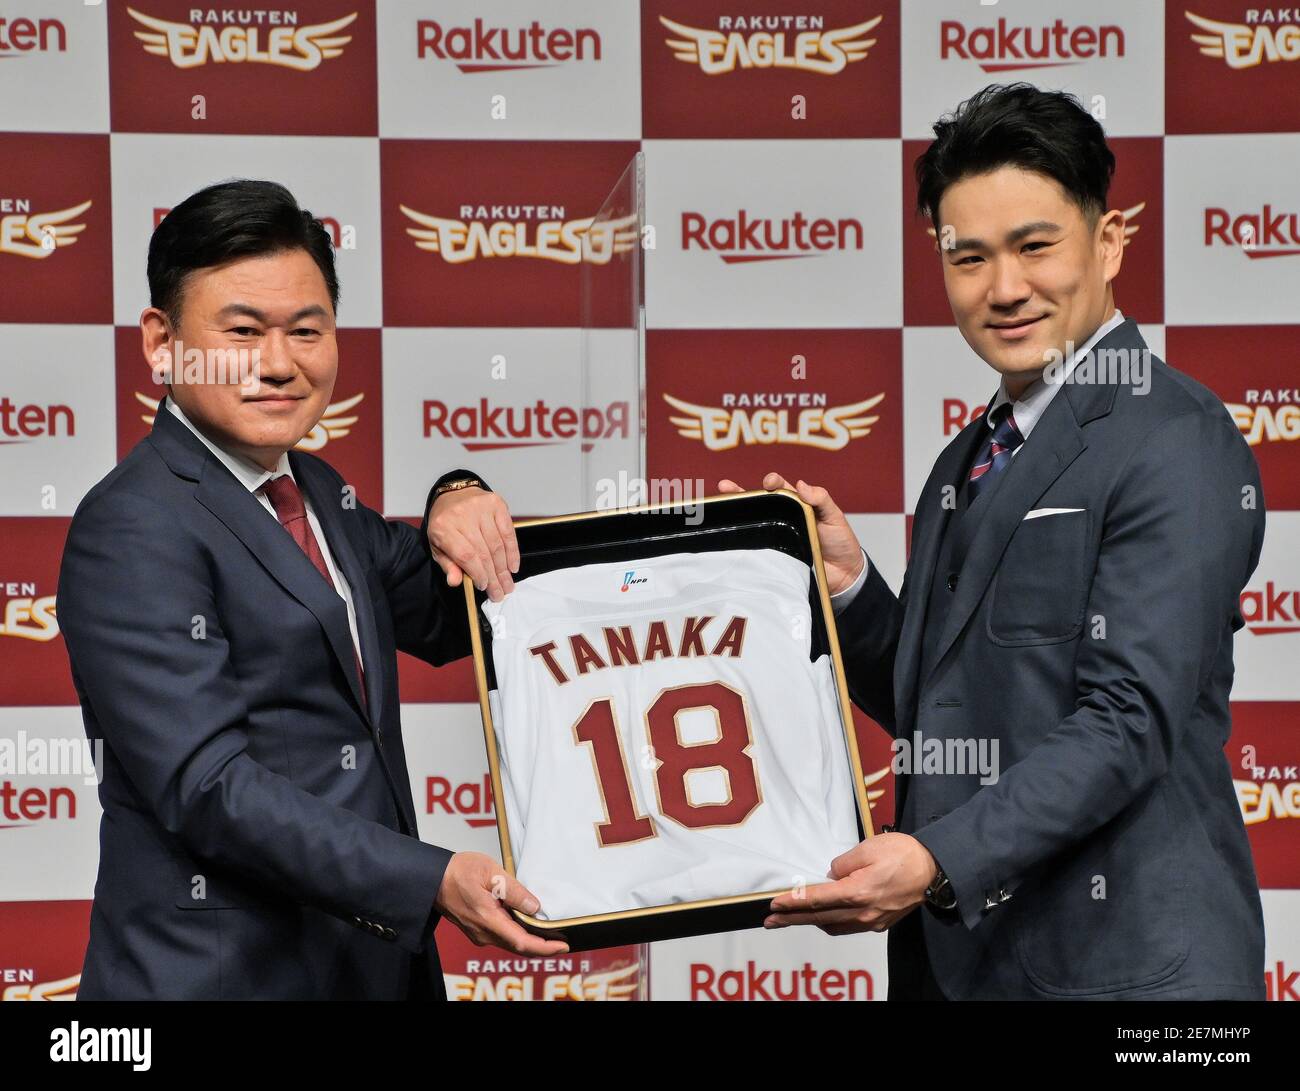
[142,250,338,469]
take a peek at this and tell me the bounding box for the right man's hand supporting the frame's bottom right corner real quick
[763,834,939,936]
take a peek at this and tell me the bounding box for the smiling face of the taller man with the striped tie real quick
[939,166,1123,397]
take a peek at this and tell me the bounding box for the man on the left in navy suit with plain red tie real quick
[59,181,566,999]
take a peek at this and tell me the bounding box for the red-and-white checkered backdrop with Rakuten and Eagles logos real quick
[0,0,1300,1000]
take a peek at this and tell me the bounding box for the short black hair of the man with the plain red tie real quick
[148,178,338,326]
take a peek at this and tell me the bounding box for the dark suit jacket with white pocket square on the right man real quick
[839,321,1264,999]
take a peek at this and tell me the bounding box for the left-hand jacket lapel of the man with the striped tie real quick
[894,415,988,723]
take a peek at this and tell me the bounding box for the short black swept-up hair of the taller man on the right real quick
[915,83,1115,230]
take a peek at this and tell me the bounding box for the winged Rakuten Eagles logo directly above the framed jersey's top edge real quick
[663,393,885,451]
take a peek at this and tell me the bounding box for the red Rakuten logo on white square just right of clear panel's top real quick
[681,208,863,264]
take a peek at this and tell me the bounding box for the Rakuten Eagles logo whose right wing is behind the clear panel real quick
[398,204,640,265]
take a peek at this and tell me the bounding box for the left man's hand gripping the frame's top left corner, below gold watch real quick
[429,485,519,602]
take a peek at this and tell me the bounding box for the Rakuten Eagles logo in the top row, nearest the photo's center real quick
[659,16,884,75]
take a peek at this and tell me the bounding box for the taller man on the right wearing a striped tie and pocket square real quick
[722,85,1264,1000]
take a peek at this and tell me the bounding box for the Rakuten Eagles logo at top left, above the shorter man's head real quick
[126,8,356,72]
